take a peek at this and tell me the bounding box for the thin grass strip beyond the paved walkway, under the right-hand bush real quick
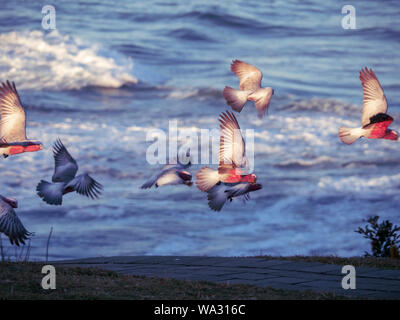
[258,256,400,269]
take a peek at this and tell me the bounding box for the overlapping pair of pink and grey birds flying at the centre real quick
[196,111,262,211]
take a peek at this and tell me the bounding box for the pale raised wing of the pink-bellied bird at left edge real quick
[0,81,27,142]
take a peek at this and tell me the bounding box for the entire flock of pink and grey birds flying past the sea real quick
[0,60,398,246]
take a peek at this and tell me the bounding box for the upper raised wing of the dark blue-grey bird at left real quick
[52,139,78,183]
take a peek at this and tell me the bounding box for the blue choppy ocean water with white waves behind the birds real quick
[0,0,400,260]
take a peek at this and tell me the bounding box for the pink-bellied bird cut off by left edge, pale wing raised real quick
[0,81,43,158]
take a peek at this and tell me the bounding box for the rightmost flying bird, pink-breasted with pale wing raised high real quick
[339,68,398,144]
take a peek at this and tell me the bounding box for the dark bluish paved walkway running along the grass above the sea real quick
[54,256,400,299]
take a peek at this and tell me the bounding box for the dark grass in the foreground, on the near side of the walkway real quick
[0,262,344,300]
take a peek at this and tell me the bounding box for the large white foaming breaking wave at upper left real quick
[0,30,137,90]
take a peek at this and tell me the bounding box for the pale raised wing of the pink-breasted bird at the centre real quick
[218,111,248,174]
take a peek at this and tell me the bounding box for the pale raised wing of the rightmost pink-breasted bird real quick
[360,68,387,126]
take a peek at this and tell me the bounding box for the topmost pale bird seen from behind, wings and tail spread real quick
[223,60,274,118]
